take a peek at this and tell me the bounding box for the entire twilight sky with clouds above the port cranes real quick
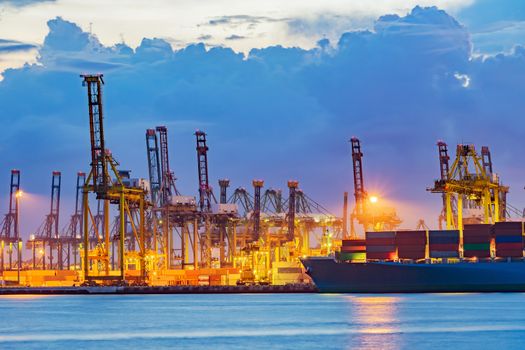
[0,0,525,236]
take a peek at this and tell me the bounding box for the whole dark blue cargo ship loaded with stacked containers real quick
[301,222,525,293]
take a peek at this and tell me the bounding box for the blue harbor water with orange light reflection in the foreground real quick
[0,293,525,350]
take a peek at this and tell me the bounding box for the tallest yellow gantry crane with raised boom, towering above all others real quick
[81,74,148,281]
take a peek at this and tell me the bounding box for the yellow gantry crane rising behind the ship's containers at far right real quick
[428,142,508,231]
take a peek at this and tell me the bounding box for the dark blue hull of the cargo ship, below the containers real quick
[301,257,525,293]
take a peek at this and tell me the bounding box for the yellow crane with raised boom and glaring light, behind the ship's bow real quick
[350,137,401,235]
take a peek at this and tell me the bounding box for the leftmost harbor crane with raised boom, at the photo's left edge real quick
[0,169,22,271]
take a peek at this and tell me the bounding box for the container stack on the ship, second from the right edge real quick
[463,224,492,258]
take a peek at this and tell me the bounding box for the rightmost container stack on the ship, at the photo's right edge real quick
[492,222,523,258]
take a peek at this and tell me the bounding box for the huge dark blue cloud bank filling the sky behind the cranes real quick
[0,7,525,238]
